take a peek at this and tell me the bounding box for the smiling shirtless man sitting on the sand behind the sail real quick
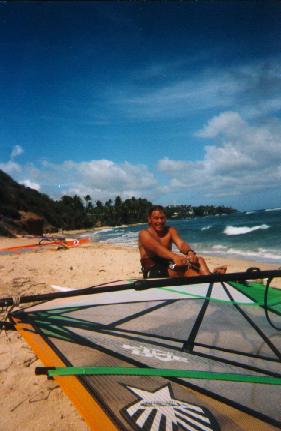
[139,205,226,278]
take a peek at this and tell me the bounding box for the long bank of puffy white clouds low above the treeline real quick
[0,111,281,209]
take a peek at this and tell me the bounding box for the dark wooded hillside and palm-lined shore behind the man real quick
[0,170,235,236]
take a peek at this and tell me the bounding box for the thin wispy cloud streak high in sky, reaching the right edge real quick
[106,57,281,121]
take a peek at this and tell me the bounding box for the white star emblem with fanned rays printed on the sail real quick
[122,384,220,431]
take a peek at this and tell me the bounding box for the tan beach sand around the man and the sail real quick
[0,237,276,431]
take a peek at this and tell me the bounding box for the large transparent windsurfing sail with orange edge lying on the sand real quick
[0,270,281,431]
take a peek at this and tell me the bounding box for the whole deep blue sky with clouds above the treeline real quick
[0,0,281,209]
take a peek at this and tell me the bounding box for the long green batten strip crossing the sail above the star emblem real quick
[42,367,281,385]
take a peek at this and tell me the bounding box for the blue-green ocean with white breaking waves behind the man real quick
[87,208,281,266]
